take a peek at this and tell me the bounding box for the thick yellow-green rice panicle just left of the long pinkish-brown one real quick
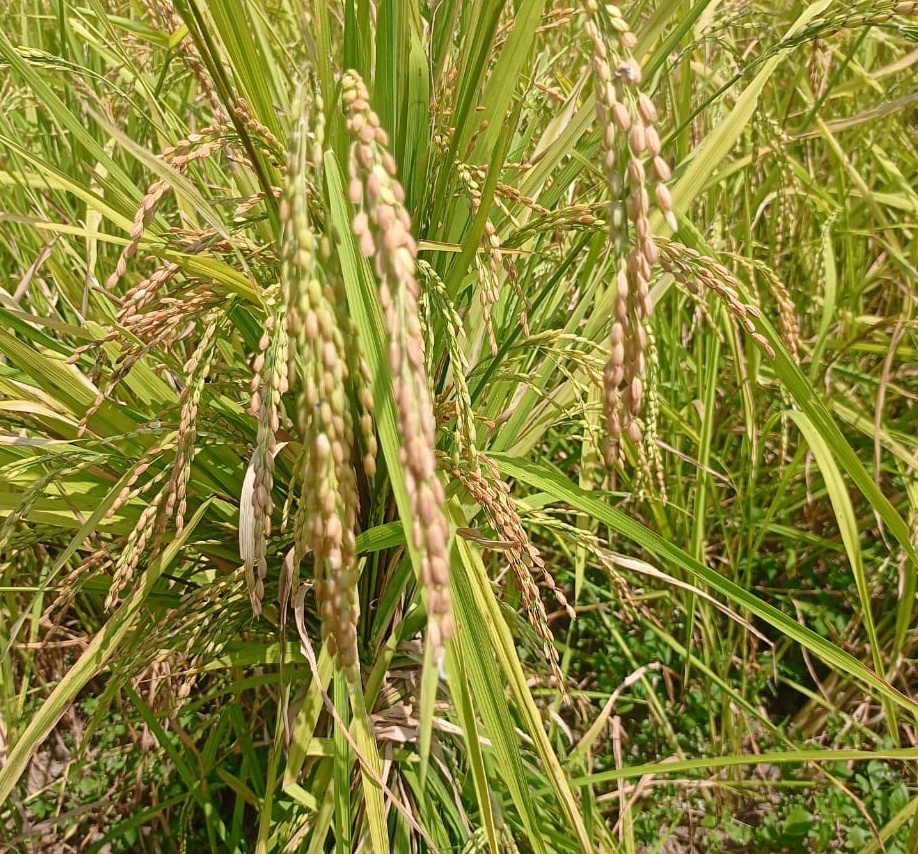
[281,85,359,681]
